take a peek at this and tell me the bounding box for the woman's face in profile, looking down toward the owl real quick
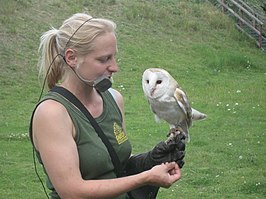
[76,33,118,81]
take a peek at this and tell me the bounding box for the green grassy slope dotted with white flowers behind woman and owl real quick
[0,0,266,199]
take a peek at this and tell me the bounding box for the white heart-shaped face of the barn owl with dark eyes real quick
[142,68,173,99]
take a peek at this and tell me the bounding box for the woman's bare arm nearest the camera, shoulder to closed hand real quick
[33,100,180,199]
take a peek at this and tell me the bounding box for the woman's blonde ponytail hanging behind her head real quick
[38,28,64,89]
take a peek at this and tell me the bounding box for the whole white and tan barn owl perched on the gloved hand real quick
[142,68,207,141]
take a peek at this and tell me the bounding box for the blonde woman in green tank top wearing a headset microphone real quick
[30,13,183,199]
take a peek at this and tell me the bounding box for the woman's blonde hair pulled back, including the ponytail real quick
[38,13,116,89]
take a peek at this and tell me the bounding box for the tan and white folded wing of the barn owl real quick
[174,87,192,128]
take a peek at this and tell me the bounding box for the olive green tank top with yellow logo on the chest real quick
[32,88,131,199]
